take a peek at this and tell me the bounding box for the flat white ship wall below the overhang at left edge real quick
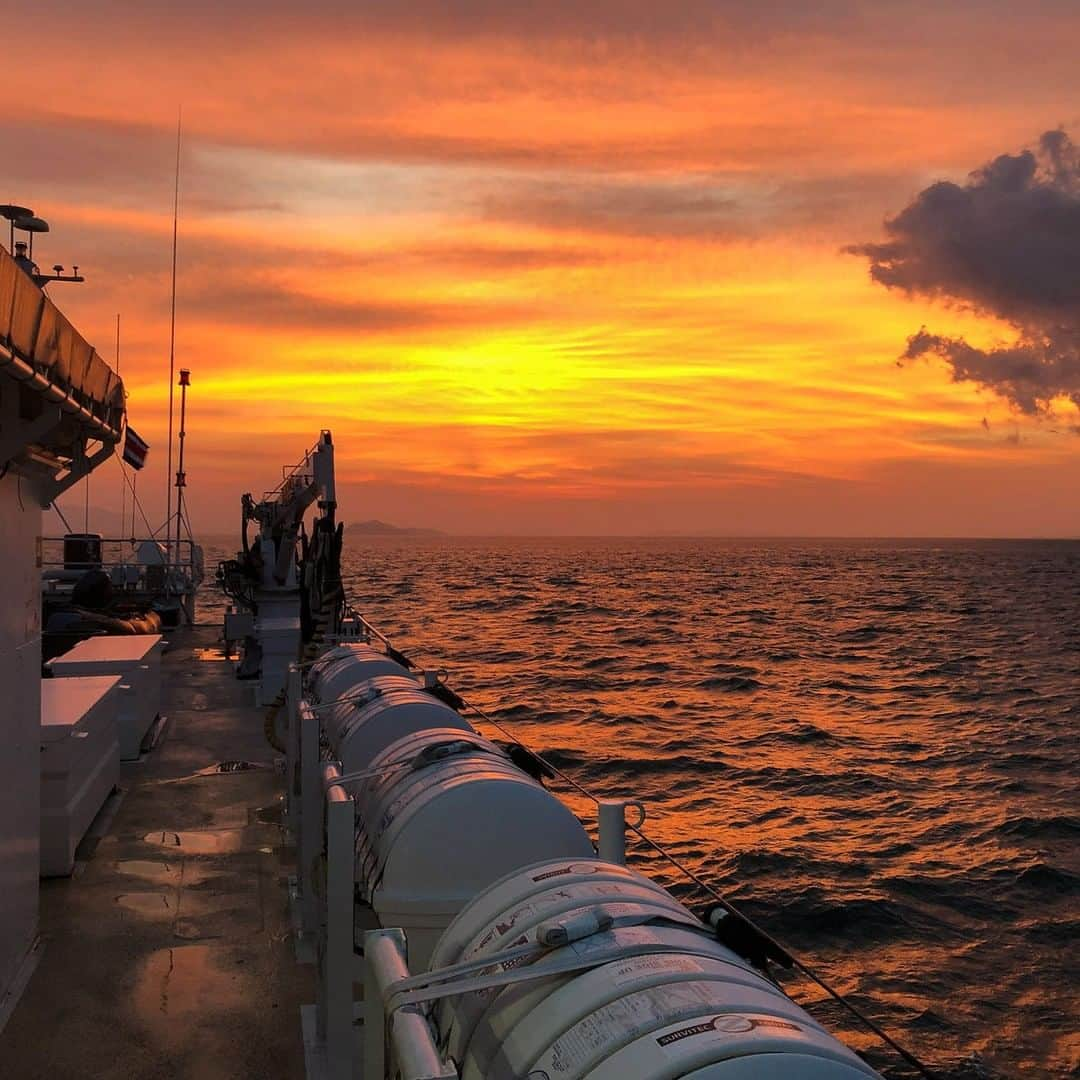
[0,473,41,1015]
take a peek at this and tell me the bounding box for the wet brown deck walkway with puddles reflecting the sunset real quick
[0,629,314,1080]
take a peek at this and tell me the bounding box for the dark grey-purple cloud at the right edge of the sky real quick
[847,131,1080,415]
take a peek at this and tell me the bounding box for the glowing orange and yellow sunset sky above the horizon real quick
[0,0,1080,536]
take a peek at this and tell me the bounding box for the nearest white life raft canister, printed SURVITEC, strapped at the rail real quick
[431,859,878,1080]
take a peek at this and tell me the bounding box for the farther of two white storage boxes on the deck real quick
[46,634,162,761]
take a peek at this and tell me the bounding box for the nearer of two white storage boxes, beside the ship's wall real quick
[41,675,121,877]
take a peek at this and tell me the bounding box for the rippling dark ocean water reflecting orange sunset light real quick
[200,538,1080,1078]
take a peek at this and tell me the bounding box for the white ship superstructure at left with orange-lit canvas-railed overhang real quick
[0,243,125,1018]
